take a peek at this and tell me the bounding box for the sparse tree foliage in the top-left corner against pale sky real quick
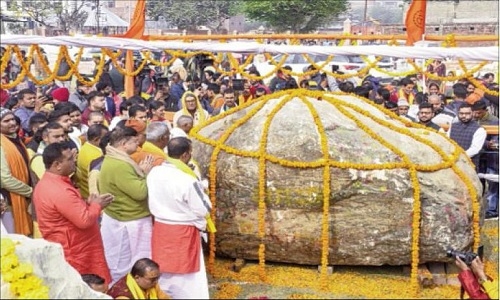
[10,0,88,34]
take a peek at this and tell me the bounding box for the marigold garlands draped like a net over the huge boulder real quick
[191,89,480,296]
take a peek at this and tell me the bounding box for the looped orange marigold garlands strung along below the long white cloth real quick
[0,41,499,96]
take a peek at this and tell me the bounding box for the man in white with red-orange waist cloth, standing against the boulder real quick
[147,137,211,299]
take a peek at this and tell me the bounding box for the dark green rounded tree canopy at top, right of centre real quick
[243,0,349,33]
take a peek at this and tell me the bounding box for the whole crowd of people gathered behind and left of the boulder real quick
[0,48,498,299]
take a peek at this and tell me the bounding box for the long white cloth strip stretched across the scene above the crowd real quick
[0,34,499,61]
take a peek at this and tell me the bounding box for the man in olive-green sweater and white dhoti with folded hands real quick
[99,127,153,285]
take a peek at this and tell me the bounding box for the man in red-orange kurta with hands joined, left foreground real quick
[33,142,113,283]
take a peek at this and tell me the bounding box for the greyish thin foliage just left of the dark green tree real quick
[146,0,239,32]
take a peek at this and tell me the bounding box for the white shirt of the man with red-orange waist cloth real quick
[147,163,212,230]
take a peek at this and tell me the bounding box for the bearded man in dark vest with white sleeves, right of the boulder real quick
[447,102,486,171]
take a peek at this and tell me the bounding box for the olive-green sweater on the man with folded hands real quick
[99,156,151,222]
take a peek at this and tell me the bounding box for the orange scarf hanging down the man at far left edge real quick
[0,134,33,235]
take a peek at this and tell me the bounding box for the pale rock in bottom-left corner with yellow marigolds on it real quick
[1,234,113,299]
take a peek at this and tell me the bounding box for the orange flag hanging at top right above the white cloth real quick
[405,0,427,46]
